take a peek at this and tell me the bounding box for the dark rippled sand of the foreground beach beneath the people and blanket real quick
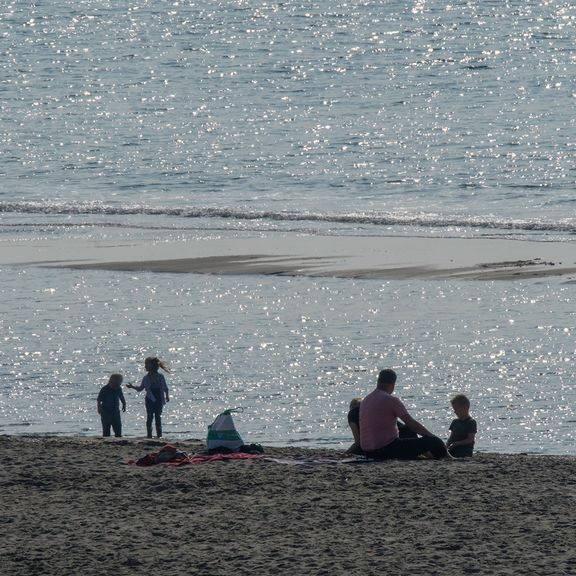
[0,436,576,576]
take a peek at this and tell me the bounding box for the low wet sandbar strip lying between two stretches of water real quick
[0,234,576,282]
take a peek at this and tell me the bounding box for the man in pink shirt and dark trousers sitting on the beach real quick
[360,369,448,460]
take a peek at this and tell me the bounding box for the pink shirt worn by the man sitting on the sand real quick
[360,389,408,452]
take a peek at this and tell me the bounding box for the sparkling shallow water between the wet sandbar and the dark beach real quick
[0,268,575,453]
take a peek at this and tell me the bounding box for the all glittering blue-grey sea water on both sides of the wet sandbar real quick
[0,0,576,454]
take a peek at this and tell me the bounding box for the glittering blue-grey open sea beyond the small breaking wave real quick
[0,0,576,222]
